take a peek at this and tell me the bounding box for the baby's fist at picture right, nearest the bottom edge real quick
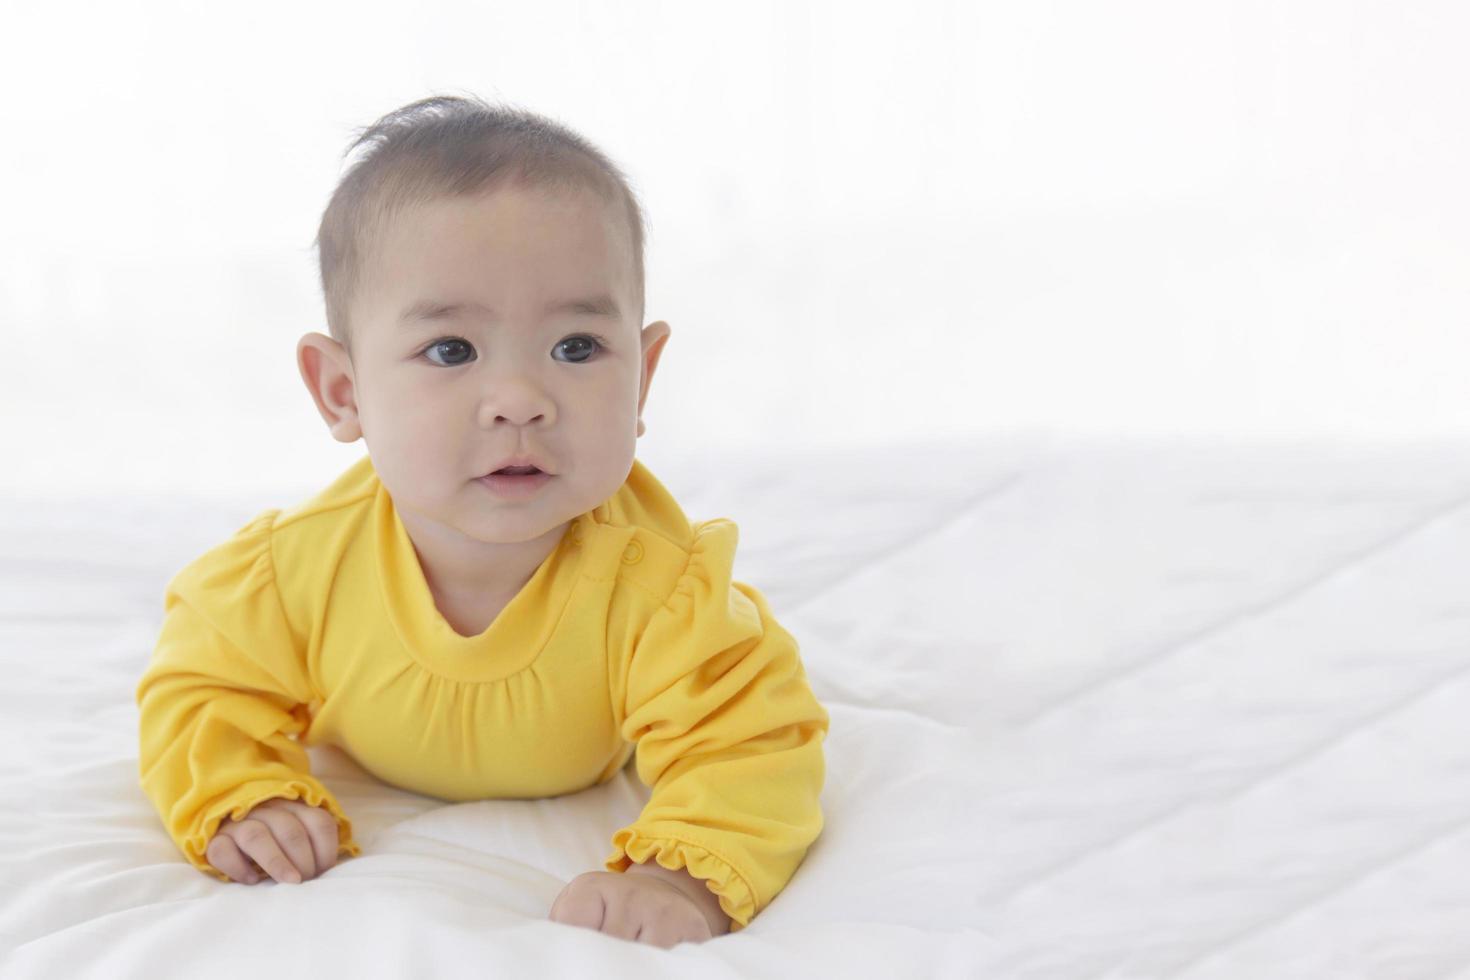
[547,871,713,949]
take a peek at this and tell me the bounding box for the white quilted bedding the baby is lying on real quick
[0,433,1470,980]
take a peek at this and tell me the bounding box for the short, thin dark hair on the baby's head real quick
[316,96,644,356]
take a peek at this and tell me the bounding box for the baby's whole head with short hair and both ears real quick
[297,97,669,544]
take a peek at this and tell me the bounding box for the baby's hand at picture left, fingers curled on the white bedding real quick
[204,798,337,884]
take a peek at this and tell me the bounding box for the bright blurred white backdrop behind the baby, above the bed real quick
[0,0,1470,505]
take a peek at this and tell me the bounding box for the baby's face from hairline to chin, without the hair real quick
[338,185,667,542]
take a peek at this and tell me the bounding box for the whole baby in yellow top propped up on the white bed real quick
[137,97,829,946]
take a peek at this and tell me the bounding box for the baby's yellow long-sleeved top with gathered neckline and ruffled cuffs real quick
[137,457,829,930]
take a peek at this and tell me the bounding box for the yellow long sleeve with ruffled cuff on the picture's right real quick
[606,519,829,932]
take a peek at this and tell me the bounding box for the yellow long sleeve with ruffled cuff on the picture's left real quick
[137,511,360,882]
